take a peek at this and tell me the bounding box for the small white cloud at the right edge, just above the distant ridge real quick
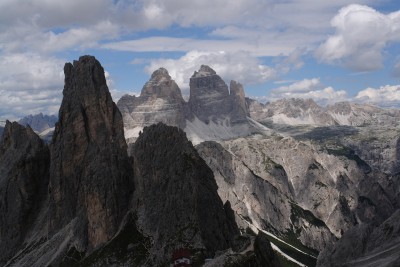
[355,85,400,107]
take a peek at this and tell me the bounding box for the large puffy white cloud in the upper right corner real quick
[315,5,400,71]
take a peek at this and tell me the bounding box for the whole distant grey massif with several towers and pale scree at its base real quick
[117,65,264,144]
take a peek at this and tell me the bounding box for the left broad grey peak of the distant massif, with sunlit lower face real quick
[118,68,187,138]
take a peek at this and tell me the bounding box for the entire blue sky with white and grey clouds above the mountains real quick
[0,0,400,123]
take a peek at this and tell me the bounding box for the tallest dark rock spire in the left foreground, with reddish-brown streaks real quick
[49,56,131,249]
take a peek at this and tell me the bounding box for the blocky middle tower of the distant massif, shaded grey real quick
[189,65,232,123]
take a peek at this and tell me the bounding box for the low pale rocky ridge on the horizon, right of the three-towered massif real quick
[247,98,400,127]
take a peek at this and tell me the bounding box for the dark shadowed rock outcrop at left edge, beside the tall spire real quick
[0,121,49,265]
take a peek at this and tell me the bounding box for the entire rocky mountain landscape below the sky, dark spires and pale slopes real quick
[0,56,400,267]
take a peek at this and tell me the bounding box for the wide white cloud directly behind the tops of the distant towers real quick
[146,51,276,92]
